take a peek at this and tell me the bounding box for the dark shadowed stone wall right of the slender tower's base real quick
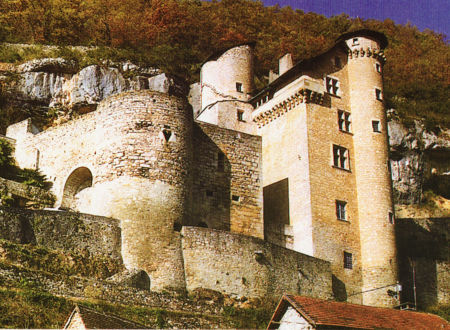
[396,218,450,308]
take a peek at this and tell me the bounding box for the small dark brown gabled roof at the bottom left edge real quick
[64,305,148,329]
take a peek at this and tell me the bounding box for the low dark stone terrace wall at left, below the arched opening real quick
[0,208,122,262]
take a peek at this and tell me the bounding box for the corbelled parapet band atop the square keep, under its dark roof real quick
[253,87,324,128]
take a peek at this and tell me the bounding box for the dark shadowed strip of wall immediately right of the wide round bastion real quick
[191,125,234,231]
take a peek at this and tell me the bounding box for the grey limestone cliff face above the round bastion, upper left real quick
[0,58,187,120]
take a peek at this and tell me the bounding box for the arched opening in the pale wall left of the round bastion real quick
[60,167,92,210]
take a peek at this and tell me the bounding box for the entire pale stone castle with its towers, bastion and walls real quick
[7,30,398,306]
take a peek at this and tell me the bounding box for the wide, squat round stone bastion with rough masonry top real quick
[89,91,193,291]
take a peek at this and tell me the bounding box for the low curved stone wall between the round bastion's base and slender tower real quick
[181,227,332,299]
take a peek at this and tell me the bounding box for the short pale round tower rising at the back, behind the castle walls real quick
[200,43,254,109]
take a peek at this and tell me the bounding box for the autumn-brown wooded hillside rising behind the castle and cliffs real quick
[0,0,450,127]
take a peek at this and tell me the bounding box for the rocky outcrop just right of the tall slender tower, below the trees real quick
[388,110,450,204]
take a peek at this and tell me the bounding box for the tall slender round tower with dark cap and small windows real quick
[340,30,398,306]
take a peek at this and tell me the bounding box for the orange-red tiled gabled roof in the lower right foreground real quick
[268,295,450,330]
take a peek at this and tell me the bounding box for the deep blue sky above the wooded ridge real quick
[263,0,450,40]
